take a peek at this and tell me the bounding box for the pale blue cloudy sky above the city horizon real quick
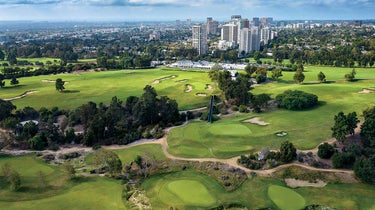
[0,0,375,21]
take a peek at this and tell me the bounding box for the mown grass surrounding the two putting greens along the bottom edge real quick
[142,171,375,210]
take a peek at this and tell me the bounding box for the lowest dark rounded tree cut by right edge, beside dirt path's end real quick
[354,155,375,183]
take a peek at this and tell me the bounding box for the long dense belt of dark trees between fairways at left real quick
[0,86,185,150]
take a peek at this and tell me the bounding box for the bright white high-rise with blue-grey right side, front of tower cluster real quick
[238,27,260,55]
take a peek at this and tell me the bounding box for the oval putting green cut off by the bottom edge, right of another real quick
[268,185,306,210]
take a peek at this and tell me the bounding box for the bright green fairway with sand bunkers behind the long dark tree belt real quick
[0,69,217,110]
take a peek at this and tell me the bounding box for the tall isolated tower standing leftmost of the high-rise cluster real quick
[192,24,208,55]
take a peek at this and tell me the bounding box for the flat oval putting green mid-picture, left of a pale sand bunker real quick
[208,124,252,136]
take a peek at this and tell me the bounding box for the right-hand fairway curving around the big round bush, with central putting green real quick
[168,67,375,158]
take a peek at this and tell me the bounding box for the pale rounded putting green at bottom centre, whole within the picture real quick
[159,180,216,207]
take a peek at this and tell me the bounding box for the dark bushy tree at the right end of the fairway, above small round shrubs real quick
[331,112,359,142]
